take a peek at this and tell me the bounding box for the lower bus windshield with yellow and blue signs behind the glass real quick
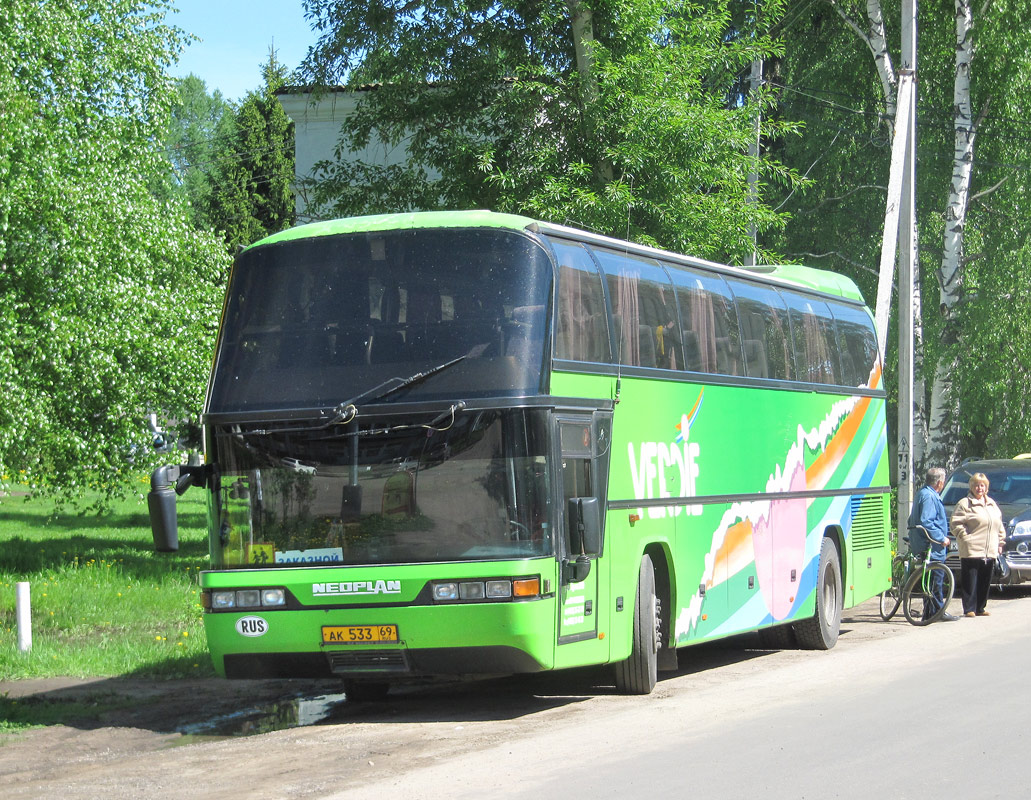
[212,409,553,568]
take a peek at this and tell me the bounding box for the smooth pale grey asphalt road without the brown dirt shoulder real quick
[323,591,1031,800]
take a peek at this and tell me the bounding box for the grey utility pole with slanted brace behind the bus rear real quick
[875,0,917,533]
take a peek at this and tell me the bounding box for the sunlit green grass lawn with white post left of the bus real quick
[0,478,213,680]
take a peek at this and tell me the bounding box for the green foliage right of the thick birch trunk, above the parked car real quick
[940,0,1031,458]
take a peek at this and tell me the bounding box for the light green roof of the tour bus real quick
[247,209,863,303]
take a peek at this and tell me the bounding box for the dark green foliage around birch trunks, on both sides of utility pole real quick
[766,0,1031,466]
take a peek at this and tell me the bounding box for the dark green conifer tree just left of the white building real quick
[205,52,294,251]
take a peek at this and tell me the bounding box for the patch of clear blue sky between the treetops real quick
[165,0,315,100]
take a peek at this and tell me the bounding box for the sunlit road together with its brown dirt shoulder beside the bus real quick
[0,591,1031,800]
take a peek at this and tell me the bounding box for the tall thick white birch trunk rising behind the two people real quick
[928,0,976,469]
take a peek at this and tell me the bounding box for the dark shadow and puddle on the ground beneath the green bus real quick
[18,587,1031,738]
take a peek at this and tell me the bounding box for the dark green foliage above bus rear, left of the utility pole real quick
[764,3,892,306]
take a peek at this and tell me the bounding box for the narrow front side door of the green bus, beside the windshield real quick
[556,413,610,666]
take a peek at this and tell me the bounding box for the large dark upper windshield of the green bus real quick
[208,229,552,413]
